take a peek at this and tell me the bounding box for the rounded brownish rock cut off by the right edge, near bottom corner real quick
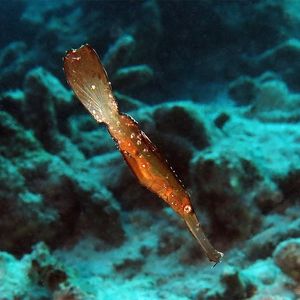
[273,238,300,282]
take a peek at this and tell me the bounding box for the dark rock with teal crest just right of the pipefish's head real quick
[191,151,261,241]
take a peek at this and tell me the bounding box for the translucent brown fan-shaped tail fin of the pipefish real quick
[63,44,118,124]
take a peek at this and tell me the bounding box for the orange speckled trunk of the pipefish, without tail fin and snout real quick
[108,114,192,216]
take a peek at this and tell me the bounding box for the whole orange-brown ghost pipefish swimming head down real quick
[63,44,223,263]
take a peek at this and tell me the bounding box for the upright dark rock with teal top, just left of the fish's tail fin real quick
[23,68,88,163]
